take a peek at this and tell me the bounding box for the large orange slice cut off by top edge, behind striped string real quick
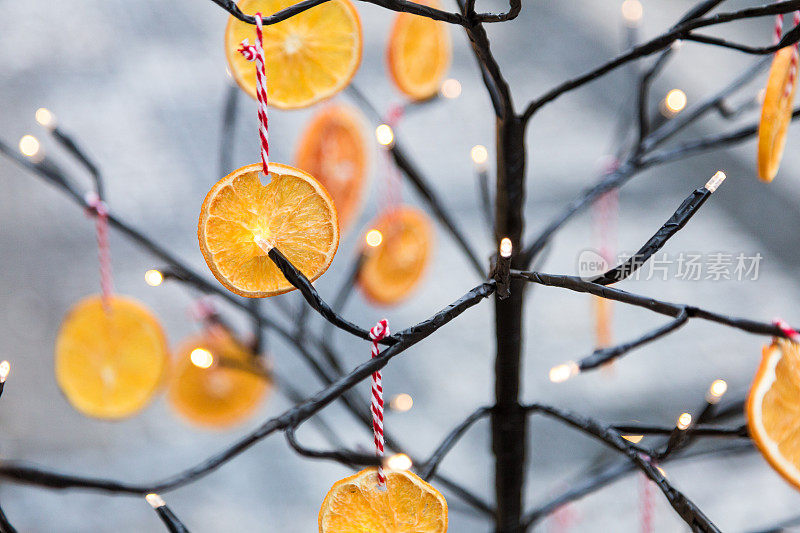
[225,0,361,109]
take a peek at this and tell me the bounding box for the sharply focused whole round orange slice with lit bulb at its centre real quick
[197,163,339,298]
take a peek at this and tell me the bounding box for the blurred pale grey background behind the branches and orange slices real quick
[0,0,800,532]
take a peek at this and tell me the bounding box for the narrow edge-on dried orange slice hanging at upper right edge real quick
[758,46,797,182]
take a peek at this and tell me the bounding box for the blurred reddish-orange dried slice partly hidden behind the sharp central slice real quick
[295,105,367,230]
